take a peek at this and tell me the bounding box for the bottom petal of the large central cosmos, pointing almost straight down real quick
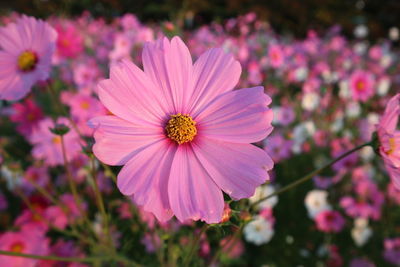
[168,145,224,223]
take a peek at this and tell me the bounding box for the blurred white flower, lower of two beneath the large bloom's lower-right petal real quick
[243,216,274,246]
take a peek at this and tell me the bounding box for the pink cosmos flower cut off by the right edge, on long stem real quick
[377,94,400,189]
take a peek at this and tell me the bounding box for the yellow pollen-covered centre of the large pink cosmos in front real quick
[165,113,197,145]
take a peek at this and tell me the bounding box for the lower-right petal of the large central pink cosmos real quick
[193,137,274,199]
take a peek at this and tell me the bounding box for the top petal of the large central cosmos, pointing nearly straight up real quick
[142,37,193,114]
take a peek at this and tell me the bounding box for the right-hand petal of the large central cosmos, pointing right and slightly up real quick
[195,86,273,143]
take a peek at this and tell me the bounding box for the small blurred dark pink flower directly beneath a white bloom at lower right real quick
[315,210,345,233]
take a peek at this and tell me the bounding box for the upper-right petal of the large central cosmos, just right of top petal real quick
[188,48,242,113]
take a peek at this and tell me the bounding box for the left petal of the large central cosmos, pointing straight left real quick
[88,116,165,165]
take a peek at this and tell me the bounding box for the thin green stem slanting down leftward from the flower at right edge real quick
[250,141,374,209]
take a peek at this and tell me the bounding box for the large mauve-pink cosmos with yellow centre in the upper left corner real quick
[0,15,57,100]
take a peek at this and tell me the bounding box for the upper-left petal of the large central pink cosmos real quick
[98,60,168,125]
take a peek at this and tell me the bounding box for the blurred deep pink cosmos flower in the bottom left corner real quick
[0,227,49,267]
